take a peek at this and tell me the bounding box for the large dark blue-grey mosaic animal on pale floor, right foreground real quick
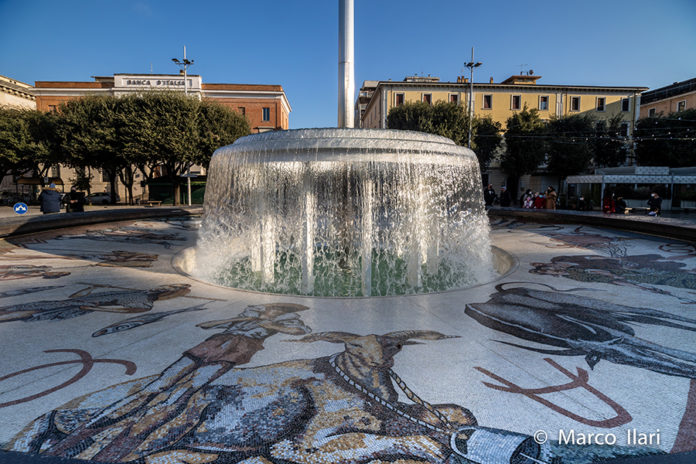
[465,285,696,379]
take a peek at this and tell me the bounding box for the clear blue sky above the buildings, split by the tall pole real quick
[0,0,696,128]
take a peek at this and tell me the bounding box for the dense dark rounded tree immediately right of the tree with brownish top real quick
[547,115,595,178]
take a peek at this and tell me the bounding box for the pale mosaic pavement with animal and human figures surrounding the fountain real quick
[0,219,696,464]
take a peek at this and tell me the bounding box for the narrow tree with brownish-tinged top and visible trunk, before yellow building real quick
[500,105,546,192]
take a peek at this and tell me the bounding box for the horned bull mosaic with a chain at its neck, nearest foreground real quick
[10,330,492,464]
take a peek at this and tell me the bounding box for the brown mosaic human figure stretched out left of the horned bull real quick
[6,303,311,462]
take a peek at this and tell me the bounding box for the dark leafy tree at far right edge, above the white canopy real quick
[635,109,696,167]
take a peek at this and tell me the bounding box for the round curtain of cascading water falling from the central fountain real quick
[193,129,493,296]
